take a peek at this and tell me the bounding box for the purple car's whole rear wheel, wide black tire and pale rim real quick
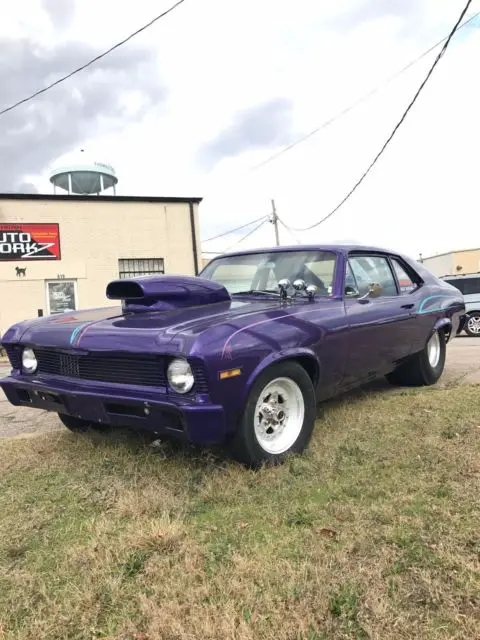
[386,330,447,387]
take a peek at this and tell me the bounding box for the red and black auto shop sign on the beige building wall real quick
[0,222,61,261]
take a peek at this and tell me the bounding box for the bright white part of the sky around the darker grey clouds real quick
[3,0,480,264]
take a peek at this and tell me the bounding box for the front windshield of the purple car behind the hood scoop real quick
[200,251,337,296]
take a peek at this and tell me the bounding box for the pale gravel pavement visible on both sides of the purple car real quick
[0,336,480,438]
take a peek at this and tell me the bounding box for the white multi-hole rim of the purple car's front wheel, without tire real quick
[254,378,305,455]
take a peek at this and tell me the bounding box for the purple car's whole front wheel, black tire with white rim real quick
[230,361,316,468]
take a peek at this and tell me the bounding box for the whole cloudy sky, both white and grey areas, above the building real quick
[0,0,480,257]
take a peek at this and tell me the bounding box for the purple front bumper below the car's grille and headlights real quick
[0,370,226,444]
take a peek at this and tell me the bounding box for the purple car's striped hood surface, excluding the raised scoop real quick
[2,299,281,354]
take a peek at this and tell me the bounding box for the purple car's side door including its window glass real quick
[345,254,412,386]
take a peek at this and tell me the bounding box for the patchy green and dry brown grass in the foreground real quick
[0,386,480,640]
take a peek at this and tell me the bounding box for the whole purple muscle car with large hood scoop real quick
[0,246,465,466]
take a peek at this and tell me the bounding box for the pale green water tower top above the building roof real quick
[50,149,118,196]
